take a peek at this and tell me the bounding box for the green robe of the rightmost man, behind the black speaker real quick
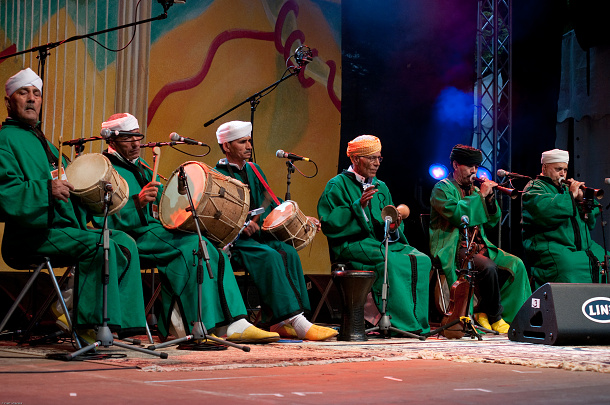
[522,176,604,286]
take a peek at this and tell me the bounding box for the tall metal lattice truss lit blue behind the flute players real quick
[473,0,513,248]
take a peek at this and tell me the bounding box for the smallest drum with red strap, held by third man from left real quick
[262,200,316,250]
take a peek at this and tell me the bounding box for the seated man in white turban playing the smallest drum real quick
[216,121,337,340]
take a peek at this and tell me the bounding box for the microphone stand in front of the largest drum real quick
[148,165,250,352]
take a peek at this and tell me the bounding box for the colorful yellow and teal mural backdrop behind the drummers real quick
[0,0,341,273]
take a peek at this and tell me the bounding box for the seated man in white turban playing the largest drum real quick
[94,113,279,343]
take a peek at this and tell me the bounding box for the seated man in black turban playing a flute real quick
[430,145,531,333]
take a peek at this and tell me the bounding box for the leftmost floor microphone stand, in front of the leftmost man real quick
[65,183,168,360]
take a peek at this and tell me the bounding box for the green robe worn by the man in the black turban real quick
[430,178,531,323]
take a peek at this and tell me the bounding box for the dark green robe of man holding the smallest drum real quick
[216,159,310,324]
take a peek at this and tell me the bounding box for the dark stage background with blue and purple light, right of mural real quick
[339,0,567,254]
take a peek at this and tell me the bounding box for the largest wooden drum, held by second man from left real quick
[159,162,250,247]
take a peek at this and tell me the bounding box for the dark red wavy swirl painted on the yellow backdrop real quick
[148,0,341,125]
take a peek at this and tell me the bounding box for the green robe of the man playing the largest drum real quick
[92,153,246,336]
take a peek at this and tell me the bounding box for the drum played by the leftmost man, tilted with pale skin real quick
[66,153,129,216]
